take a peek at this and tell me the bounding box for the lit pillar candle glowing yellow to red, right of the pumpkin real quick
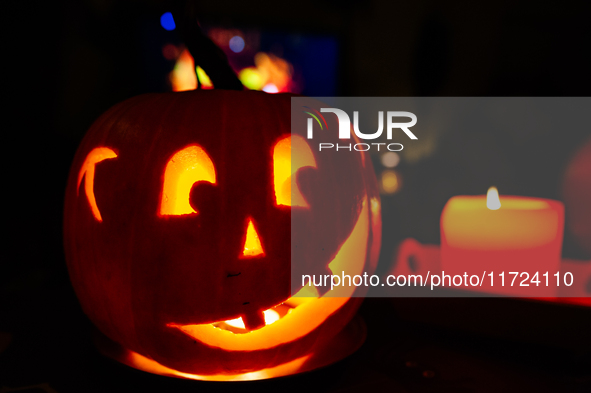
[441,187,564,296]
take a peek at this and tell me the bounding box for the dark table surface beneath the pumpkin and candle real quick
[0,283,591,393]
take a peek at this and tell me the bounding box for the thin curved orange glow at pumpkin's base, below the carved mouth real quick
[123,350,311,381]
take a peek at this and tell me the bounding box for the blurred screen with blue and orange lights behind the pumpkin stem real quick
[157,26,337,96]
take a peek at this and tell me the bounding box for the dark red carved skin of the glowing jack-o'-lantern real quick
[64,90,381,375]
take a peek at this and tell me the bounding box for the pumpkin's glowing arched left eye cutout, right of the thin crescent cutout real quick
[160,145,216,215]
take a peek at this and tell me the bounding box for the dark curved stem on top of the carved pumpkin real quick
[171,0,244,90]
